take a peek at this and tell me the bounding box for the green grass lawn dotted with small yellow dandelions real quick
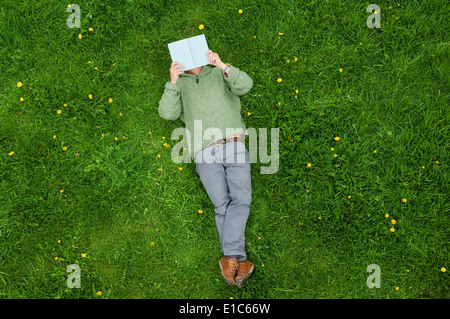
[0,0,450,299]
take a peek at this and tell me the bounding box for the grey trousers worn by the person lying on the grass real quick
[195,142,252,261]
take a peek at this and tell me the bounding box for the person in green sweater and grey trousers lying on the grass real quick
[158,50,255,288]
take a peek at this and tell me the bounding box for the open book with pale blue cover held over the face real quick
[168,34,209,71]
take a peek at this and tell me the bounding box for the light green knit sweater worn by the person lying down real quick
[158,65,253,158]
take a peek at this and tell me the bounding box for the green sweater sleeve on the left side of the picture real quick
[158,82,183,120]
